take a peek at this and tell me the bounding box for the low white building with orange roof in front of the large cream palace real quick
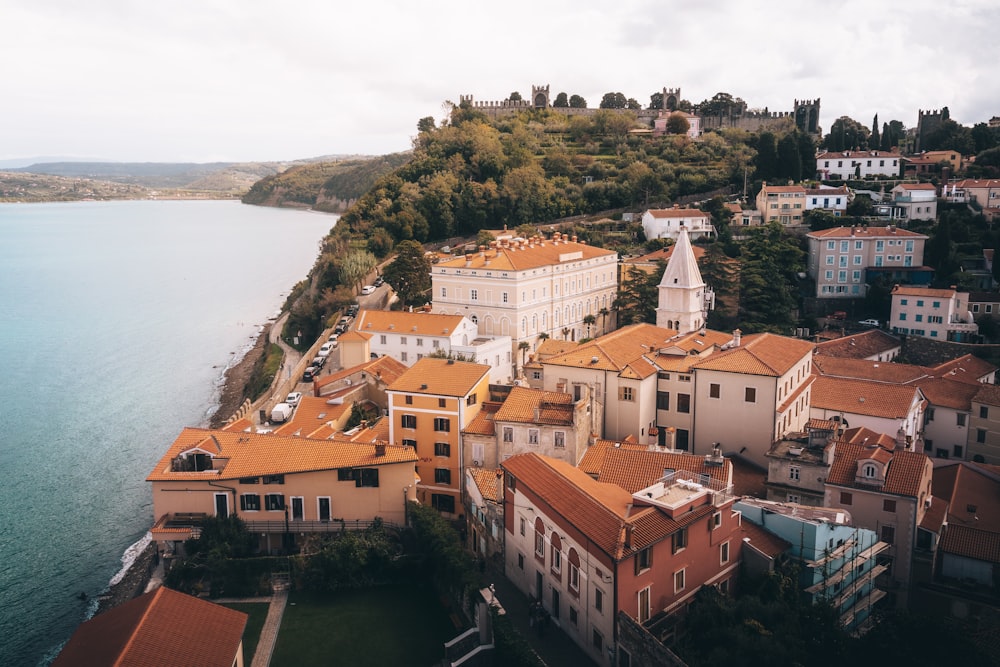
[341,310,513,384]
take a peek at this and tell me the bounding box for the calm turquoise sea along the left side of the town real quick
[0,201,336,665]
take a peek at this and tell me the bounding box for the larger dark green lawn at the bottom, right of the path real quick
[271,586,458,667]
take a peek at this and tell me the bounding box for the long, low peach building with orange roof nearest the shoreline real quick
[146,428,416,554]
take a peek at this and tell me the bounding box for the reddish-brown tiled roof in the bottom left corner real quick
[52,586,247,667]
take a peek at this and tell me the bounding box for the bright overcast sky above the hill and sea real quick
[0,0,1000,162]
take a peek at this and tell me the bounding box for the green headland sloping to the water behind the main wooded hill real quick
[243,153,412,212]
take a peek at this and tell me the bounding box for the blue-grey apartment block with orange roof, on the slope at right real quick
[806,225,933,298]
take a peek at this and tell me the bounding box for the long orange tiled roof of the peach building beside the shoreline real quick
[146,430,417,482]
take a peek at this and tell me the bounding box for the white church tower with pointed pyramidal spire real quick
[656,227,715,334]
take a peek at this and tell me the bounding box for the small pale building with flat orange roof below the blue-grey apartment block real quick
[889,285,979,342]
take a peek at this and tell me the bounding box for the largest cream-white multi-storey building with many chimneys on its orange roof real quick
[431,232,618,374]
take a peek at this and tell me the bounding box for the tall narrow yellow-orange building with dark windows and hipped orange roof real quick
[387,357,490,515]
